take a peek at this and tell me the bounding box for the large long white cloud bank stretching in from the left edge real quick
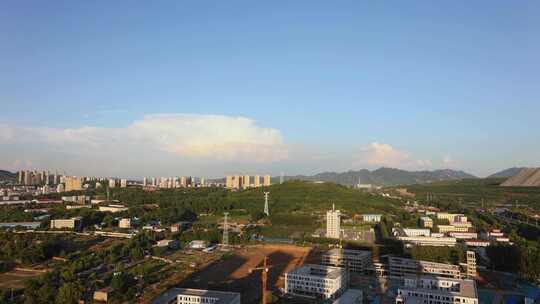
[0,114,288,163]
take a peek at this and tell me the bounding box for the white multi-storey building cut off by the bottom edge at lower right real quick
[396,276,478,304]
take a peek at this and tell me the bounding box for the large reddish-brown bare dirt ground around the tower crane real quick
[181,244,320,303]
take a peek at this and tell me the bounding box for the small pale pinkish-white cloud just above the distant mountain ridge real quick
[353,142,432,169]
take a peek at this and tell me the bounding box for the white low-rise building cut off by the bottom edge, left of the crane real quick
[150,288,240,304]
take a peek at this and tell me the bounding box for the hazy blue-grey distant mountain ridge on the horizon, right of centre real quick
[285,168,475,186]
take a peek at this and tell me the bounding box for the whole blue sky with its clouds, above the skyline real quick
[0,1,540,176]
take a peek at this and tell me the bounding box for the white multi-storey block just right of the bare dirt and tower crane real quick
[285,264,349,300]
